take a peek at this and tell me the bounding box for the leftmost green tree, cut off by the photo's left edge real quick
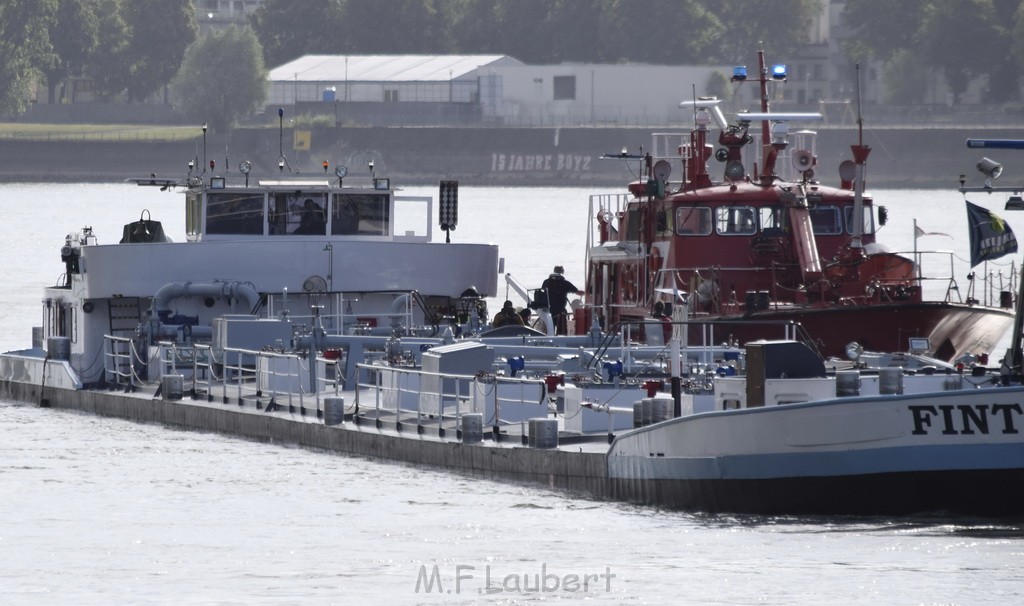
[0,0,56,116]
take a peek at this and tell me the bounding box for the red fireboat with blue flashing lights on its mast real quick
[575,51,1015,361]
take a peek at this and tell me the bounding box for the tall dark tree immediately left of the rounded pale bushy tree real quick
[125,0,199,101]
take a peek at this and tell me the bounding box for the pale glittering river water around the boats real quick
[0,184,1024,604]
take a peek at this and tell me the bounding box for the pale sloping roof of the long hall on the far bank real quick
[268,54,519,82]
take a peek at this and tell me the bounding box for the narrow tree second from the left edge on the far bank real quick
[43,0,99,103]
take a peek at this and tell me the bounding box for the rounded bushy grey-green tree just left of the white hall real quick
[171,27,267,132]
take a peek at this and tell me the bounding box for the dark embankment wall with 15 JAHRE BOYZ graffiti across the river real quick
[0,126,1024,189]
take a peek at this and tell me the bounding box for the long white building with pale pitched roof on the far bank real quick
[267,55,757,126]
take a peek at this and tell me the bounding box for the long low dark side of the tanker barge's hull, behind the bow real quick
[0,381,610,499]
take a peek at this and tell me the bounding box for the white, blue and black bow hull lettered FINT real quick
[608,386,1024,514]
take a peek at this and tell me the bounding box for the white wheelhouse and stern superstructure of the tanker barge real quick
[39,169,500,383]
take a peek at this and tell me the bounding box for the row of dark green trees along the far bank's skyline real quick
[6,0,1024,124]
